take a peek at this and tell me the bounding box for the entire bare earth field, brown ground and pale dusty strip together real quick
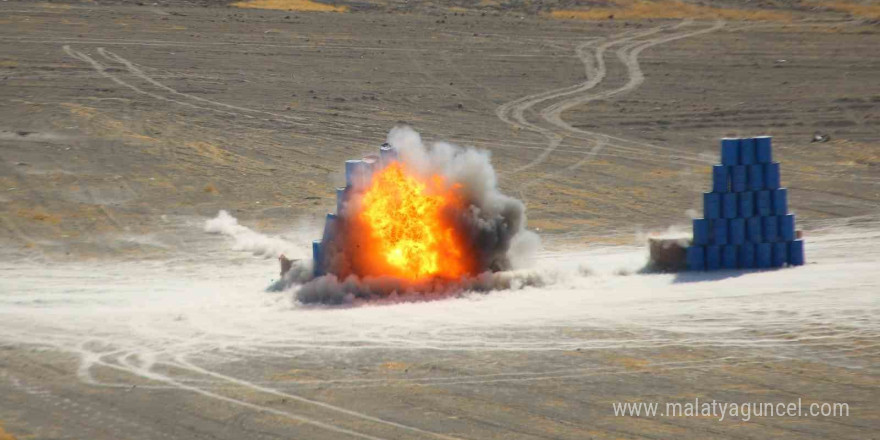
[0,1,880,440]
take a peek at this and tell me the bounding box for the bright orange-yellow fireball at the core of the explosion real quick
[358,162,471,280]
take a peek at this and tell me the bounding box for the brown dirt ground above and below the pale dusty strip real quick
[0,0,880,440]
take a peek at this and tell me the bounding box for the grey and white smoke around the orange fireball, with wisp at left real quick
[220,126,548,304]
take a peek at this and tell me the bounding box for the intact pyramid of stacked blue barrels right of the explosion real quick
[687,136,804,270]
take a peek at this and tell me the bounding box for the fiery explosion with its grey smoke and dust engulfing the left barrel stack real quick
[273,127,540,303]
